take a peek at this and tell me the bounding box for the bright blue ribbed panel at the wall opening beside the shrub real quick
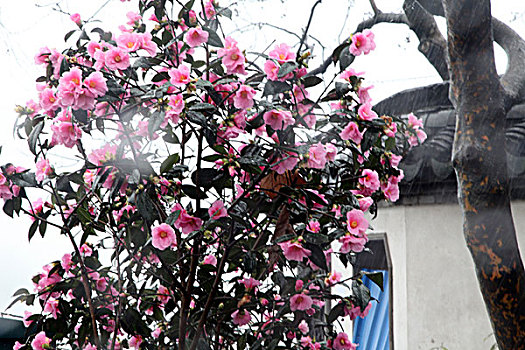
[353,269,390,350]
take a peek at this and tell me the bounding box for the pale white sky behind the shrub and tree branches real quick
[0,0,525,314]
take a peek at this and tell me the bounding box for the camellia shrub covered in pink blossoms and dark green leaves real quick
[4,1,425,350]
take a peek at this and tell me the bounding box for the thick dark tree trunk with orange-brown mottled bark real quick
[444,0,525,350]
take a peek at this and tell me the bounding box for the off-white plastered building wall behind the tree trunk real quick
[371,202,525,350]
